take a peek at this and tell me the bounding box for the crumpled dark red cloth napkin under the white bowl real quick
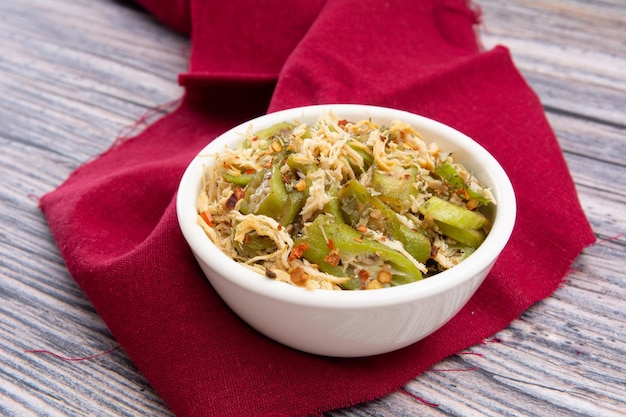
[41,0,594,416]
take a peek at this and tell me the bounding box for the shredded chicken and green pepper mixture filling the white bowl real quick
[197,113,495,290]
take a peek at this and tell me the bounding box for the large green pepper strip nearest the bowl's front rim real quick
[294,214,422,285]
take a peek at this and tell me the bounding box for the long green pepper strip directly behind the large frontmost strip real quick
[339,180,431,263]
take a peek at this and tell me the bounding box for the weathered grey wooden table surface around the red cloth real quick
[0,0,626,417]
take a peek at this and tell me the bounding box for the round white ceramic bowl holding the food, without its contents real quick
[177,104,516,357]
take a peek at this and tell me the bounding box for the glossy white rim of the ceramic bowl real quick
[176,104,516,309]
